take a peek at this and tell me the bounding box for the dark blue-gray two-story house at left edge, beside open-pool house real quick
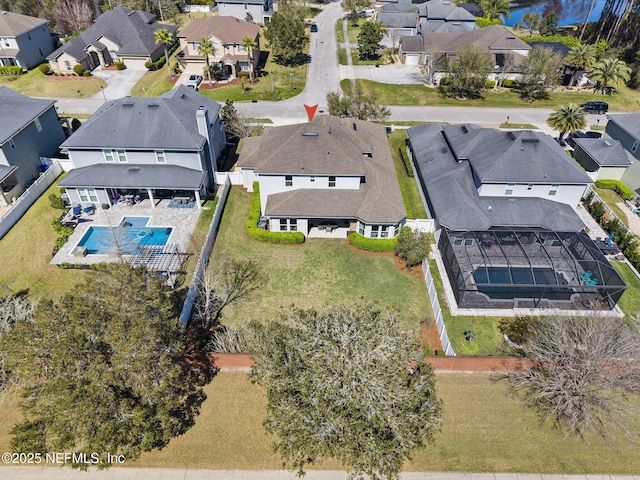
[0,86,65,205]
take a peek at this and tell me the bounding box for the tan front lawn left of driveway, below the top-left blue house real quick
[0,68,107,98]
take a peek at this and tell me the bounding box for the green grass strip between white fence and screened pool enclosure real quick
[429,260,506,355]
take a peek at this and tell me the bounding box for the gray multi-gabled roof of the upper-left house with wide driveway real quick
[47,7,178,60]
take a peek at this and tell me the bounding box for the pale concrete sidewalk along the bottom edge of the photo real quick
[0,467,640,480]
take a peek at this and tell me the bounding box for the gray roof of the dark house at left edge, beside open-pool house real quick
[0,86,55,145]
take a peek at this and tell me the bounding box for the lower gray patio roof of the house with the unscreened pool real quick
[60,163,206,190]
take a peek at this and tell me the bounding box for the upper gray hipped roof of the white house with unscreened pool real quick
[60,85,220,150]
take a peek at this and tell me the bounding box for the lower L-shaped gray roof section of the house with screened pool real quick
[407,124,588,231]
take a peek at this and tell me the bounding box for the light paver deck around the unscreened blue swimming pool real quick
[50,200,202,265]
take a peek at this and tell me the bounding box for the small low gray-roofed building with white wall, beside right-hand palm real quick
[573,138,631,181]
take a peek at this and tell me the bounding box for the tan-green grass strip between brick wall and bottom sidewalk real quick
[124,372,640,474]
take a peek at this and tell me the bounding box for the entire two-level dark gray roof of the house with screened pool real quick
[407,124,592,231]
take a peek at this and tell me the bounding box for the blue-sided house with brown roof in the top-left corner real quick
[0,11,53,70]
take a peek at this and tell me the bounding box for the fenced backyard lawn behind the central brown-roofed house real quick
[211,187,429,328]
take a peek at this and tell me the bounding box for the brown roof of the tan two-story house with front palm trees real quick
[178,16,260,43]
